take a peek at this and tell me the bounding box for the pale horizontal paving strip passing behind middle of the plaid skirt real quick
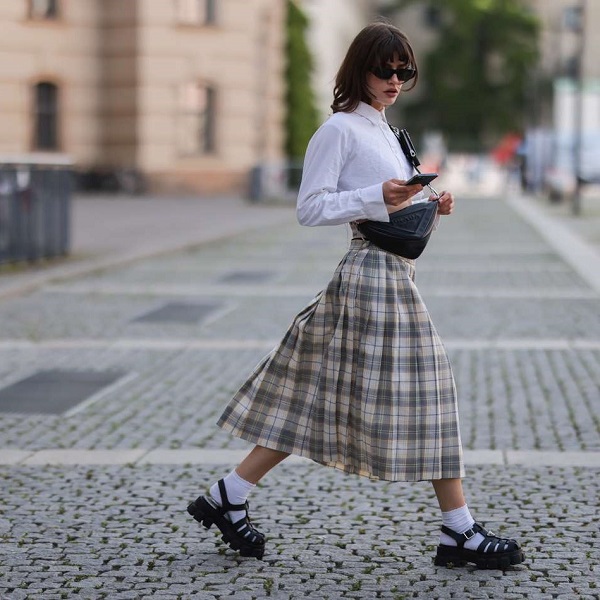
[0,338,600,352]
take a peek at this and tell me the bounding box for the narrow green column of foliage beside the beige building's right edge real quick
[285,0,319,160]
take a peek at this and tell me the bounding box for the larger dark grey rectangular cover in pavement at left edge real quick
[0,370,125,415]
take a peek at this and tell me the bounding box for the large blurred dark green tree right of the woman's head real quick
[398,0,539,149]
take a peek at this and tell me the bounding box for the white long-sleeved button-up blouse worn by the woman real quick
[296,102,427,226]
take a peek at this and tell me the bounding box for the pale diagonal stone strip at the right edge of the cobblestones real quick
[505,194,600,293]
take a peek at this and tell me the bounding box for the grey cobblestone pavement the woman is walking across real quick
[0,198,600,600]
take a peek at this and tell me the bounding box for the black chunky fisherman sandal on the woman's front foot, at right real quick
[433,523,525,569]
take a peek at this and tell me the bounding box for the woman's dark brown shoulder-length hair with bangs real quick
[331,23,419,113]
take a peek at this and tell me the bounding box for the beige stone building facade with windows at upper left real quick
[0,0,285,193]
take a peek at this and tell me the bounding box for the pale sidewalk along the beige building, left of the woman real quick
[0,195,294,298]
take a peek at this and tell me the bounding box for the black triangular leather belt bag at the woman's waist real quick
[358,200,438,258]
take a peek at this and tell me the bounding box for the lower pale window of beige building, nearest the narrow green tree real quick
[177,83,215,156]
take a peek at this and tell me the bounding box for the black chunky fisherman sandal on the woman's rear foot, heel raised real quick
[187,479,266,558]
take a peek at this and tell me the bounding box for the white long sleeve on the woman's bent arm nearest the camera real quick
[296,123,389,226]
